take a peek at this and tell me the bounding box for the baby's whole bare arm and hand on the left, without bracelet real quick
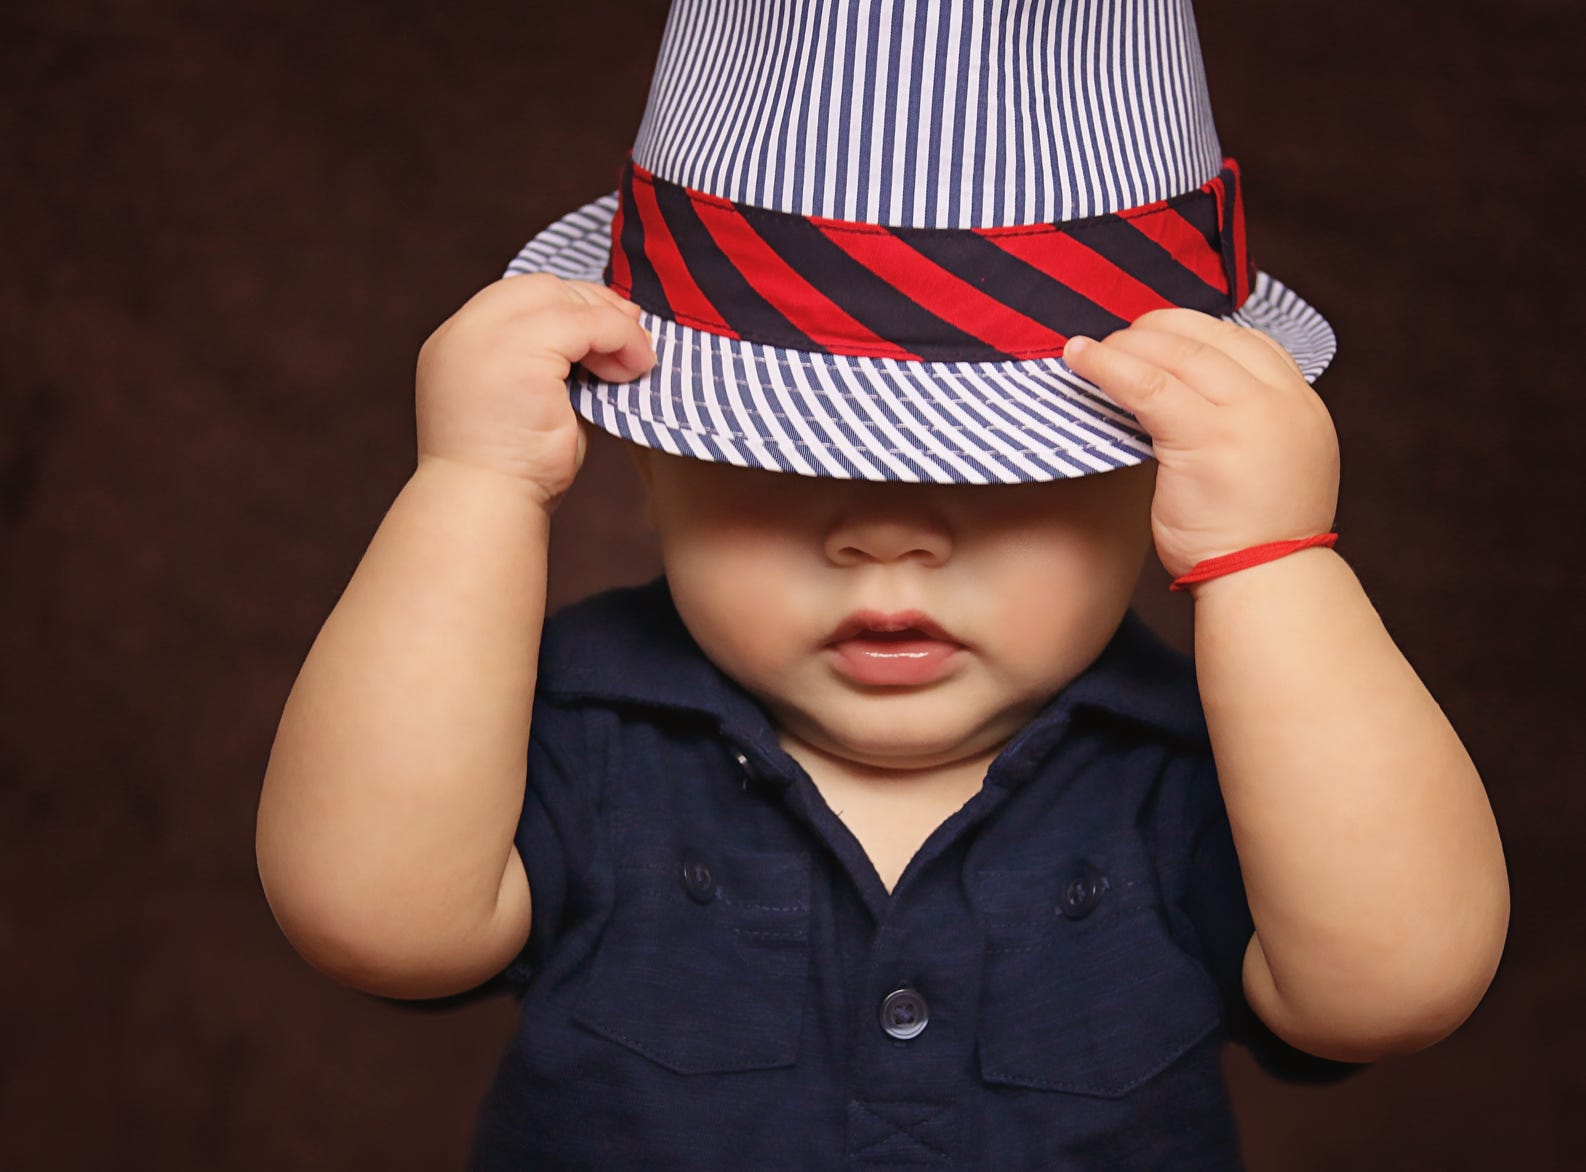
[257,276,653,998]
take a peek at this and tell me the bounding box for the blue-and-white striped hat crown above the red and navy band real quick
[633,0,1223,228]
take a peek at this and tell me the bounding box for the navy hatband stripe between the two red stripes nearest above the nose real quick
[739,208,989,362]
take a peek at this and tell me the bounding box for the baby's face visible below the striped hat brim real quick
[638,449,1156,769]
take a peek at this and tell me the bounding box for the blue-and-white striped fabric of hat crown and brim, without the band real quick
[508,0,1335,484]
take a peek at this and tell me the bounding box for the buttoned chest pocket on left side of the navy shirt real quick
[574,826,810,1074]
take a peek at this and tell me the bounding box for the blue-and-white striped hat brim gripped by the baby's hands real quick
[506,193,1337,484]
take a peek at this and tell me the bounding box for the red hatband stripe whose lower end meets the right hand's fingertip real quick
[812,220,1069,355]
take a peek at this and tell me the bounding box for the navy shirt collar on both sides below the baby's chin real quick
[539,577,1207,761]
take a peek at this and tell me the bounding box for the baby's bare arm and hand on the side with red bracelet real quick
[1067,309,1508,1061]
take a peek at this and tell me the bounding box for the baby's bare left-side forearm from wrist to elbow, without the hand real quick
[257,460,549,996]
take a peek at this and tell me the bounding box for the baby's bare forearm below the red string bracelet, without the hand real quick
[1194,549,1508,1059]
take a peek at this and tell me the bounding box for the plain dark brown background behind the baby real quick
[0,0,1586,1170]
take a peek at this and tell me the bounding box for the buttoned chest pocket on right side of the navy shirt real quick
[977,839,1221,1099]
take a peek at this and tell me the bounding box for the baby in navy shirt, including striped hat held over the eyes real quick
[259,0,1508,1169]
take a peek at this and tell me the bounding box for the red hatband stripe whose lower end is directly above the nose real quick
[688,192,920,360]
